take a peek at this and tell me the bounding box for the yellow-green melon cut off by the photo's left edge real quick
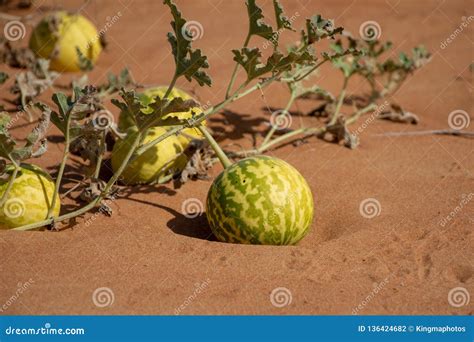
[0,164,61,229]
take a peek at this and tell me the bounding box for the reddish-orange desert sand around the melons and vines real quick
[0,0,474,315]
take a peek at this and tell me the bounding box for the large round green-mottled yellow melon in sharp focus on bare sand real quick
[207,156,313,245]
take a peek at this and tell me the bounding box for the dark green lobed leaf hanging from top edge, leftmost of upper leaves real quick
[164,0,212,86]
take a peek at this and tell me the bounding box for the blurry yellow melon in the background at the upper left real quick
[30,11,102,72]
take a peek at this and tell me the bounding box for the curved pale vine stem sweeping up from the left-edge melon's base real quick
[12,133,141,231]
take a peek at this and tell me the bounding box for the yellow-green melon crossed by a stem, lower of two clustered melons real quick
[112,127,186,185]
